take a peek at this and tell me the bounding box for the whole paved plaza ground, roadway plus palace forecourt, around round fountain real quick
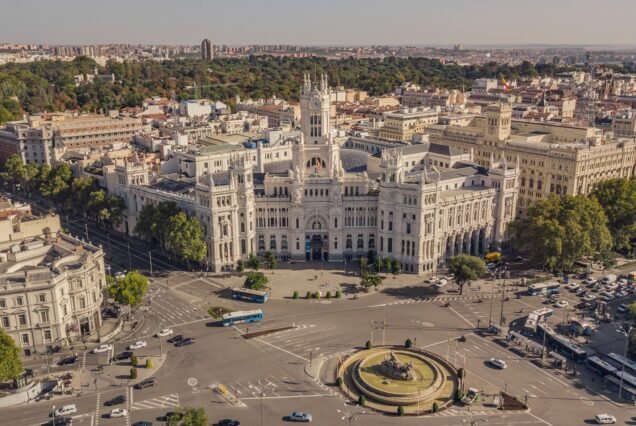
[2,265,636,426]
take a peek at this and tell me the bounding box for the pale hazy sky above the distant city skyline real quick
[0,0,636,45]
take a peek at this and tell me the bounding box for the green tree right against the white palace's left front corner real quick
[166,211,208,263]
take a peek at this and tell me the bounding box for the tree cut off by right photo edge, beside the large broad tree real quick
[590,178,636,252]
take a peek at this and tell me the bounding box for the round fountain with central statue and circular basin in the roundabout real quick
[336,346,460,415]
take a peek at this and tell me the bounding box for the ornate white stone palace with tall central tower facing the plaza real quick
[110,76,519,274]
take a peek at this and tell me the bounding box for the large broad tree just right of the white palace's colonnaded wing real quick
[510,195,612,270]
